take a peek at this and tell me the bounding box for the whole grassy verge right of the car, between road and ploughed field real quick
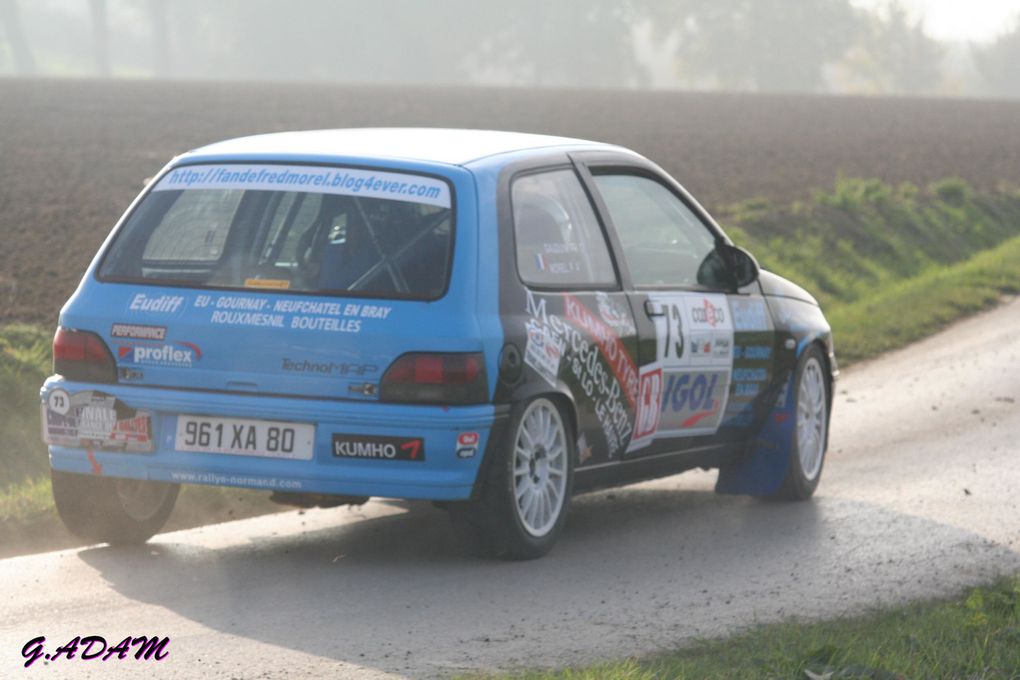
[720,178,1020,366]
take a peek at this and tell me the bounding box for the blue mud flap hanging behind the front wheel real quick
[715,373,797,495]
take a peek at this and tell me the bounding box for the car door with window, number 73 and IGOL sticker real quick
[584,158,775,458]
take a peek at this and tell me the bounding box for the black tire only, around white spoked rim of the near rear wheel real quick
[449,397,576,560]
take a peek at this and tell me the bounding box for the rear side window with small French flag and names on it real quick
[511,169,616,287]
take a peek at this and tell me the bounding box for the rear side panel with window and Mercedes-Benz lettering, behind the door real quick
[497,164,638,468]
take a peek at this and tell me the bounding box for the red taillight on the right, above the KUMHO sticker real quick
[379,354,489,404]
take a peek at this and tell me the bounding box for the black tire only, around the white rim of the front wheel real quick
[769,345,831,501]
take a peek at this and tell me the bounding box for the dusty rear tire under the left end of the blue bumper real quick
[50,470,181,545]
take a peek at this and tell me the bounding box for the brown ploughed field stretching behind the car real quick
[0,80,1020,325]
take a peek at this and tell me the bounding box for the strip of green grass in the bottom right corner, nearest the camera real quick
[465,578,1020,680]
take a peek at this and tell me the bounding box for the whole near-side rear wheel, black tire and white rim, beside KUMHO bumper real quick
[450,398,574,560]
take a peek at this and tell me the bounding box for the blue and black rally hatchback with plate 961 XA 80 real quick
[41,129,836,559]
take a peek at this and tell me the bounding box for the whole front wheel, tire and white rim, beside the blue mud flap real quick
[774,346,829,501]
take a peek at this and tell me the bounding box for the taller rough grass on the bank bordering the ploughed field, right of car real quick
[719,178,1020,313]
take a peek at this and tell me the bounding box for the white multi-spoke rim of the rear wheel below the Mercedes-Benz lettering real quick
[513,399,569,537]
